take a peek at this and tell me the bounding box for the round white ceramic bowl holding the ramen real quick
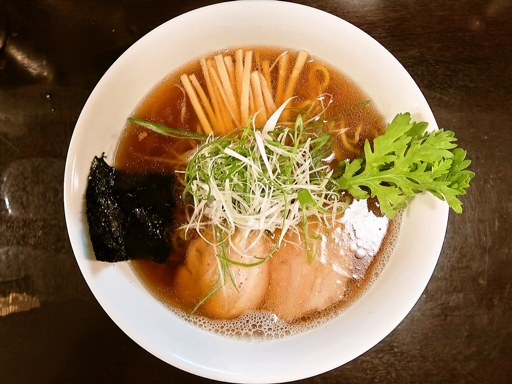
[64,1,448,383]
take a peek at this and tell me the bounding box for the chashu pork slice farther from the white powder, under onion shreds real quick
[174,231,272,319]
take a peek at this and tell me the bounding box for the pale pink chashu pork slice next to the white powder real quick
[263,223,353,323]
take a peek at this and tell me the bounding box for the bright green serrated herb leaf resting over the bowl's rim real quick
[336,113,474,219]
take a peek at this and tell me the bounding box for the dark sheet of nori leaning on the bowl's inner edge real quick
[85,156,176,263]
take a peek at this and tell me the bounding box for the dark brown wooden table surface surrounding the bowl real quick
[0,0,512,384]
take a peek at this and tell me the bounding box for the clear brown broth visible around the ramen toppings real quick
[115,47,398,335]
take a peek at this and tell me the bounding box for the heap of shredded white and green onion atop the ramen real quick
[184,105,347,255]
